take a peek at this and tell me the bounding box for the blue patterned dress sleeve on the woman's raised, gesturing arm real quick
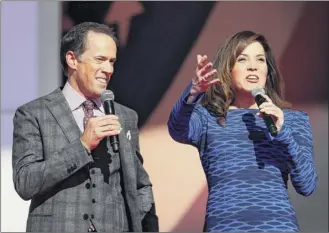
[167,84,204,146]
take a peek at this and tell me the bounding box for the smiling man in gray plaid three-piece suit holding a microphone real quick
[13,22,158,232]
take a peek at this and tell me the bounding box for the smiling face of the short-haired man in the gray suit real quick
[69,32,117,98]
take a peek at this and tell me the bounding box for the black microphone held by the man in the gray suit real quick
[101,90,119,152]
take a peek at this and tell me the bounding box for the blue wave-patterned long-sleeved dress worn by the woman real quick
[168,83,317,232]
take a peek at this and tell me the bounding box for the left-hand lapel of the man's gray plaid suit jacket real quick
[47,88,81,142]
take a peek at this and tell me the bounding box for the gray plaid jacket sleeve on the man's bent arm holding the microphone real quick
[12,107,92,200]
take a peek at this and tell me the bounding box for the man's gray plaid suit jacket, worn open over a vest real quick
[12,88,158,232]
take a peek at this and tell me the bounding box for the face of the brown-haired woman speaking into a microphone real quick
[232,42,267,93]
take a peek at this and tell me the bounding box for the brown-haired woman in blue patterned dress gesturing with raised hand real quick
[168,31,317,232]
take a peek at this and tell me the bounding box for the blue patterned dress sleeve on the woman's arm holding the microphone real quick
[275,111,318,196]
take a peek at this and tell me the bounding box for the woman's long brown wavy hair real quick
[201,31,291,125]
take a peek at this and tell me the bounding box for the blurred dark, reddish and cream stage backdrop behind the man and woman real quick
[1,1,329,232]
